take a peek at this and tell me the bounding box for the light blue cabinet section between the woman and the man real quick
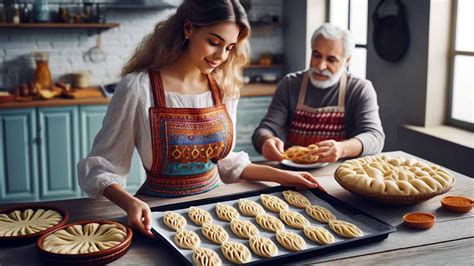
[234,96,272,161]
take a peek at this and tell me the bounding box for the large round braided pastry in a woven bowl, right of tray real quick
[334,155,454,204]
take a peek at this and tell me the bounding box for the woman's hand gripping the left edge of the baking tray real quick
[125,198,155,238]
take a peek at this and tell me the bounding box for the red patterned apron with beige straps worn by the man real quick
[288,71,347,146]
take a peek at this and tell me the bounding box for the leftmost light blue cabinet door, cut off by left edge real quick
[0,109,39,202]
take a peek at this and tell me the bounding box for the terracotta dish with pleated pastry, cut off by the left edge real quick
[0,205,69,242]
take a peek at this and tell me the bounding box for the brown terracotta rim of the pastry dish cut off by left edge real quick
[0,204,69,244]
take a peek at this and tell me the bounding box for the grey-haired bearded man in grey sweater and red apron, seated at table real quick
[252,23,385,162]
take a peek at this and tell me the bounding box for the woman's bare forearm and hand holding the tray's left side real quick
[103,184,154,237]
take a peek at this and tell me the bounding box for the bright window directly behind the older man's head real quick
[329,0,368,78]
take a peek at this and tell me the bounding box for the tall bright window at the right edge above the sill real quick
[448,0,474,131]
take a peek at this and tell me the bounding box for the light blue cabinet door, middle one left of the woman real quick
[38,106,80,200]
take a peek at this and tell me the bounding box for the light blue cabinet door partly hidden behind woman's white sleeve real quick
[79,105,146,194]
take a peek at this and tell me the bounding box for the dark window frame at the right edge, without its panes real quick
[448,0,474,131]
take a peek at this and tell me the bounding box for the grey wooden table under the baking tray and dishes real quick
[0,151,474,265]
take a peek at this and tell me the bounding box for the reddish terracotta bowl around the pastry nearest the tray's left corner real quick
[36,220,133,265]
